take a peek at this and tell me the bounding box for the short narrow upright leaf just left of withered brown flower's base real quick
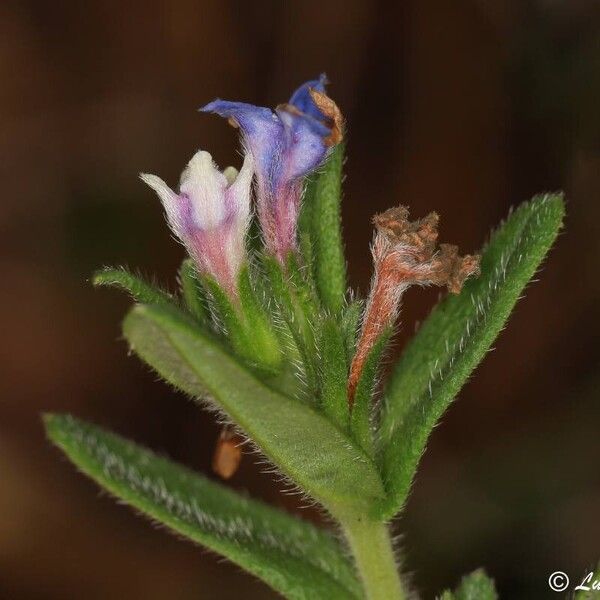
[319,317,350,431]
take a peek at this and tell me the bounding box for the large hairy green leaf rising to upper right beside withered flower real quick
[380,194,564,518]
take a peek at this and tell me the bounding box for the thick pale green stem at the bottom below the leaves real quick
[340,517,406,600]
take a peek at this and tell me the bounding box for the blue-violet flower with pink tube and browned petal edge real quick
[200,75,341,263]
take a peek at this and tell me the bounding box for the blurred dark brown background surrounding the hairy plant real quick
[0,0,600,600]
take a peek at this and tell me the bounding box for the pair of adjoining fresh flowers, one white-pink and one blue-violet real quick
[141,75,342,299]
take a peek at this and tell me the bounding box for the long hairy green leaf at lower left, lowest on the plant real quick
[44,415,360,600]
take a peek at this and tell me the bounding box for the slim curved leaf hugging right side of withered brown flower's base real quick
[350,327,393,457]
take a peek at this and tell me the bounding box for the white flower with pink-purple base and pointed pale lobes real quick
[140,150,254,298]
